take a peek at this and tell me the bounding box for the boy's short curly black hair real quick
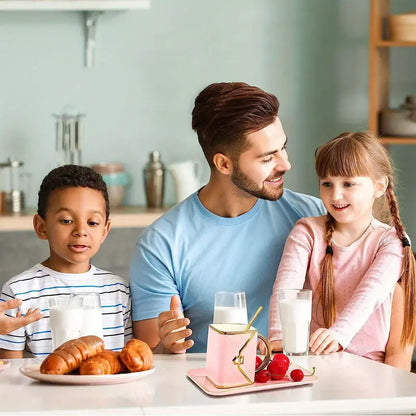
[38,165,110,221]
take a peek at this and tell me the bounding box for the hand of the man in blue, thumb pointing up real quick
[158,295,194,354]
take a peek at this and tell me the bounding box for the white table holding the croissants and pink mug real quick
[0,352,416,416]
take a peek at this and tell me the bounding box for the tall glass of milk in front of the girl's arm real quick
[277,289,312,355]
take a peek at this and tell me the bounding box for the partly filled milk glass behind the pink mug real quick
[213,292,248,324]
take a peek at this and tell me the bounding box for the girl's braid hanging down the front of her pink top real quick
[321,214,337,328]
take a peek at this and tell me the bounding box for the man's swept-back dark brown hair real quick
[192,82,279,166]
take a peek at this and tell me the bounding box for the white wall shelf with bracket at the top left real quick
[0,0,150,68]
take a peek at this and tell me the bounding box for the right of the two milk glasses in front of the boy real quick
[74,292,103,339]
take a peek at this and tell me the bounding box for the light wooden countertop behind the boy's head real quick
[0,207,168,232]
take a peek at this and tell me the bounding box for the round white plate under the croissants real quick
[20,365,155,384]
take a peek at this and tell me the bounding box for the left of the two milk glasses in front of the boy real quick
[49,294,83,350]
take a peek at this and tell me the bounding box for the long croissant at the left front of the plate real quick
[40,335,104,374]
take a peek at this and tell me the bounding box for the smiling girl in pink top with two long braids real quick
[269,132,416,370]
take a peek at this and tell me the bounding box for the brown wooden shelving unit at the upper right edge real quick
[368,0,416,145]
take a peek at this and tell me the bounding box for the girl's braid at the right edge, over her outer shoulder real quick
[386,182,416,345]
